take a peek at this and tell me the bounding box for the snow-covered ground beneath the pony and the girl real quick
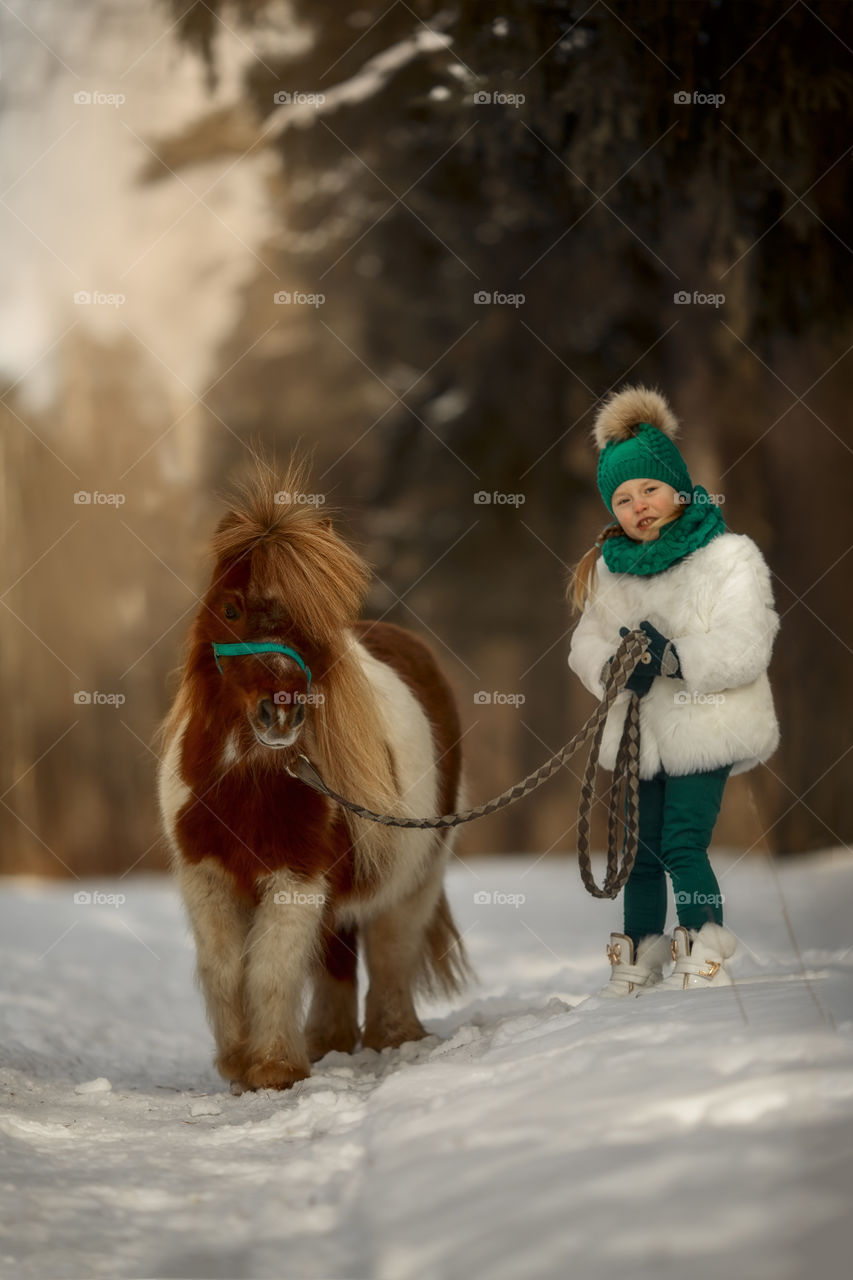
[0,850,853,1280]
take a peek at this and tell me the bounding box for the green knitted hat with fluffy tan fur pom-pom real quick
[593,387,693,515]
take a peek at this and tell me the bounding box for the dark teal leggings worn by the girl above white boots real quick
[625,764,731,946]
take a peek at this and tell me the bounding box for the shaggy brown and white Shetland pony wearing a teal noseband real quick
[159,461,470,1092]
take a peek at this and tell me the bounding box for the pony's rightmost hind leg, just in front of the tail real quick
[361,859,444,1050]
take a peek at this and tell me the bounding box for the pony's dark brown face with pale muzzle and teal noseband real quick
[204,585,319,750]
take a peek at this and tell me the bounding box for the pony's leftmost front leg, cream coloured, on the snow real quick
[175,858,254,1080]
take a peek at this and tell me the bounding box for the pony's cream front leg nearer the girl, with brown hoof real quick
[243,869,325,1089]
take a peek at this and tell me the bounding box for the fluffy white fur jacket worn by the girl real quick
[569,532,779,778]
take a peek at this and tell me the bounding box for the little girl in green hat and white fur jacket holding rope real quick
[569,387,779,996]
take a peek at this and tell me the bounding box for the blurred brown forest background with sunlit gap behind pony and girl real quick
[0,0,853,876]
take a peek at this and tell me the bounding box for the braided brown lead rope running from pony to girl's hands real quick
[286,631,648,897]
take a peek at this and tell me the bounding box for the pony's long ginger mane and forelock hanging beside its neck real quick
[211,456,403,876]
